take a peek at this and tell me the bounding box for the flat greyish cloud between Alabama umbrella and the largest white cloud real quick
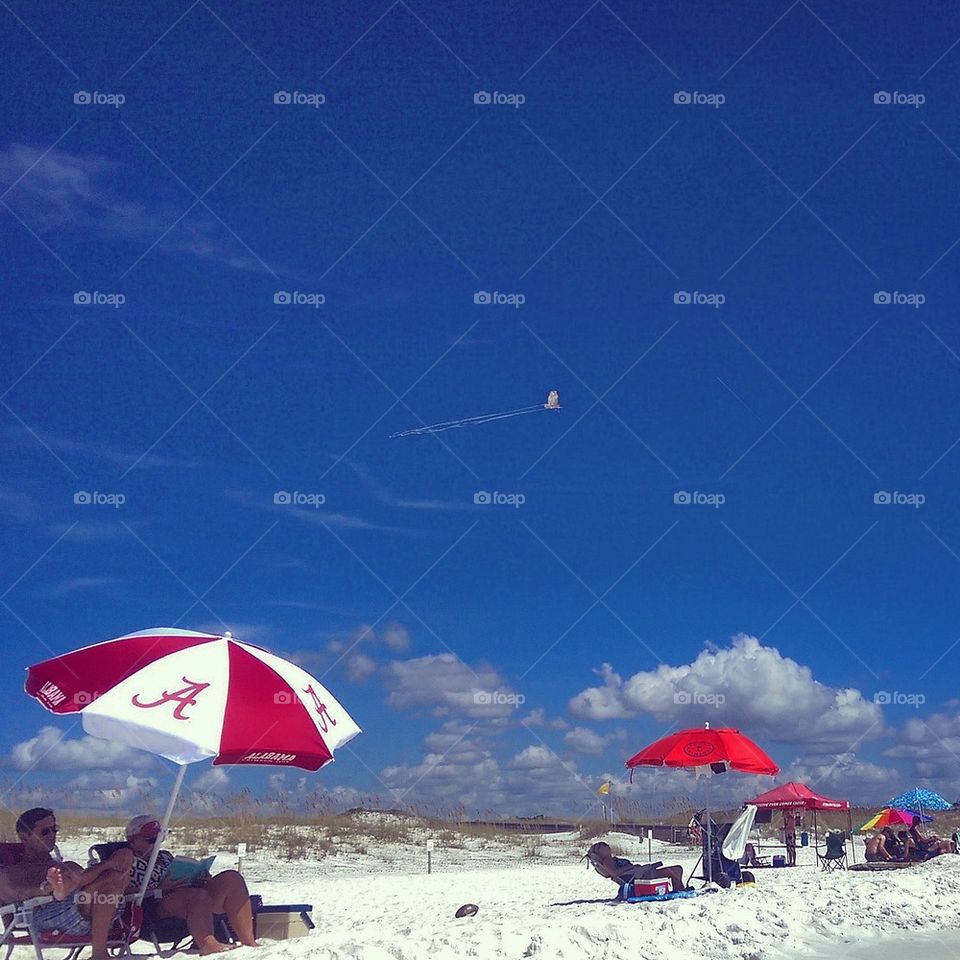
[384,653,518,719]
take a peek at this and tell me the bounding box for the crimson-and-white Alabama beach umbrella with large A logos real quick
[25,627,360,896]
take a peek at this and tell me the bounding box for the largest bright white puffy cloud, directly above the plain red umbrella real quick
[568,634,886,749]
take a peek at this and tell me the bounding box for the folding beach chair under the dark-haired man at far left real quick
[0,843,141,960]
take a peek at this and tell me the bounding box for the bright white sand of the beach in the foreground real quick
[52,835,960,960]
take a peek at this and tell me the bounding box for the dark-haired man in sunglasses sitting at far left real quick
[0,807,133,960]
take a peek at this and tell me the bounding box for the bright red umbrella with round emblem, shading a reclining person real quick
[627,723,780,881]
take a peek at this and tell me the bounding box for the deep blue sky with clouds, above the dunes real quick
[0,0,960,813]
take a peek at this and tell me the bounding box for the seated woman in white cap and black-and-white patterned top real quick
[126,816,260,956]
